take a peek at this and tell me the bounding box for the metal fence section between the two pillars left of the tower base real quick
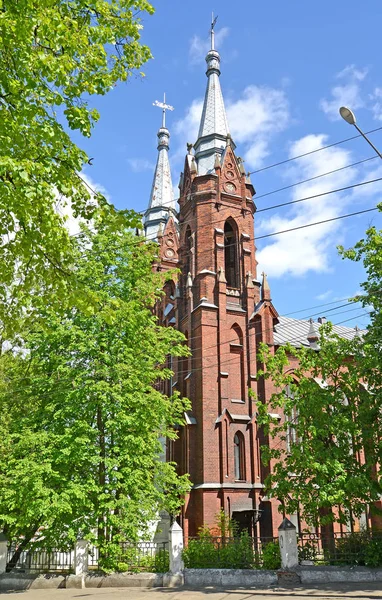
[88,542,169,573]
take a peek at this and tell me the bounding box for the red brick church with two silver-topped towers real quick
[145,27,364,537]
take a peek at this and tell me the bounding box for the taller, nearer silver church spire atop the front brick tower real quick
[195,15,229,175]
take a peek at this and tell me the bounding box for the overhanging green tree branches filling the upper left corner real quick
[0,0,153,340]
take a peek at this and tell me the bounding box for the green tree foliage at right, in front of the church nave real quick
[258,218,382,525]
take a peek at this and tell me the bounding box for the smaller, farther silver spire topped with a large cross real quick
[144,94,176,240]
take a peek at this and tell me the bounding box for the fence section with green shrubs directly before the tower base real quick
[183,535,281,569]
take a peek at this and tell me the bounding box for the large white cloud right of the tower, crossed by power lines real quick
[256,135,357,277]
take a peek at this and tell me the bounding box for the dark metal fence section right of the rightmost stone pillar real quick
[298,531,382,567]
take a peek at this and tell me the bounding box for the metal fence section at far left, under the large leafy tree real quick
[7,547,74,573]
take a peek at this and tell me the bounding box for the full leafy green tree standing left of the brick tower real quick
[0,215,189,568]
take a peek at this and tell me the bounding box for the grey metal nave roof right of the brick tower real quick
[274,317,362,348]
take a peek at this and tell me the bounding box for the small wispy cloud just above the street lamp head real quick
[320,65,368,121]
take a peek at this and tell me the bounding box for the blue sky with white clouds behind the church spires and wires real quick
[75,0,382,327]
